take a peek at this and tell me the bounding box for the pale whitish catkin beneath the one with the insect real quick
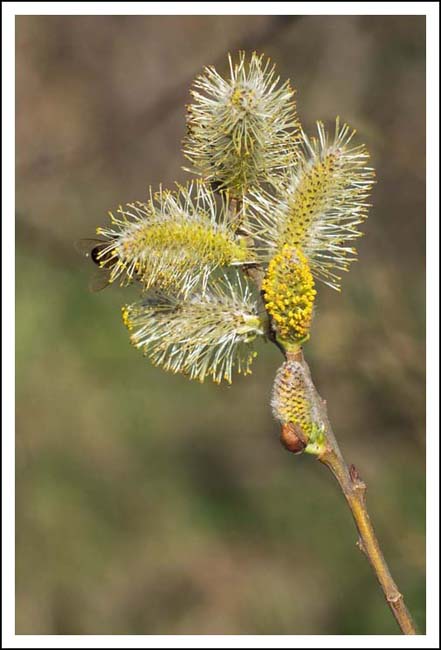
[122,271,264,383]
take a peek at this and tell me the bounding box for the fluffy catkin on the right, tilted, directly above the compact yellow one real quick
[245,118,375,291]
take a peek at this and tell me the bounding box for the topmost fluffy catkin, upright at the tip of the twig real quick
[184,52,300,197]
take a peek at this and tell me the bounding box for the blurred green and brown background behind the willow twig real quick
[16,16,425,634]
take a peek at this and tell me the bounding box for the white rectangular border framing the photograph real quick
[2,2,439,648]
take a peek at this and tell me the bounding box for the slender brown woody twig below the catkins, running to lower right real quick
[286,350,418,634]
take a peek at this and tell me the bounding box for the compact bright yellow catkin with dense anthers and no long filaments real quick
[262,246,317,346]
